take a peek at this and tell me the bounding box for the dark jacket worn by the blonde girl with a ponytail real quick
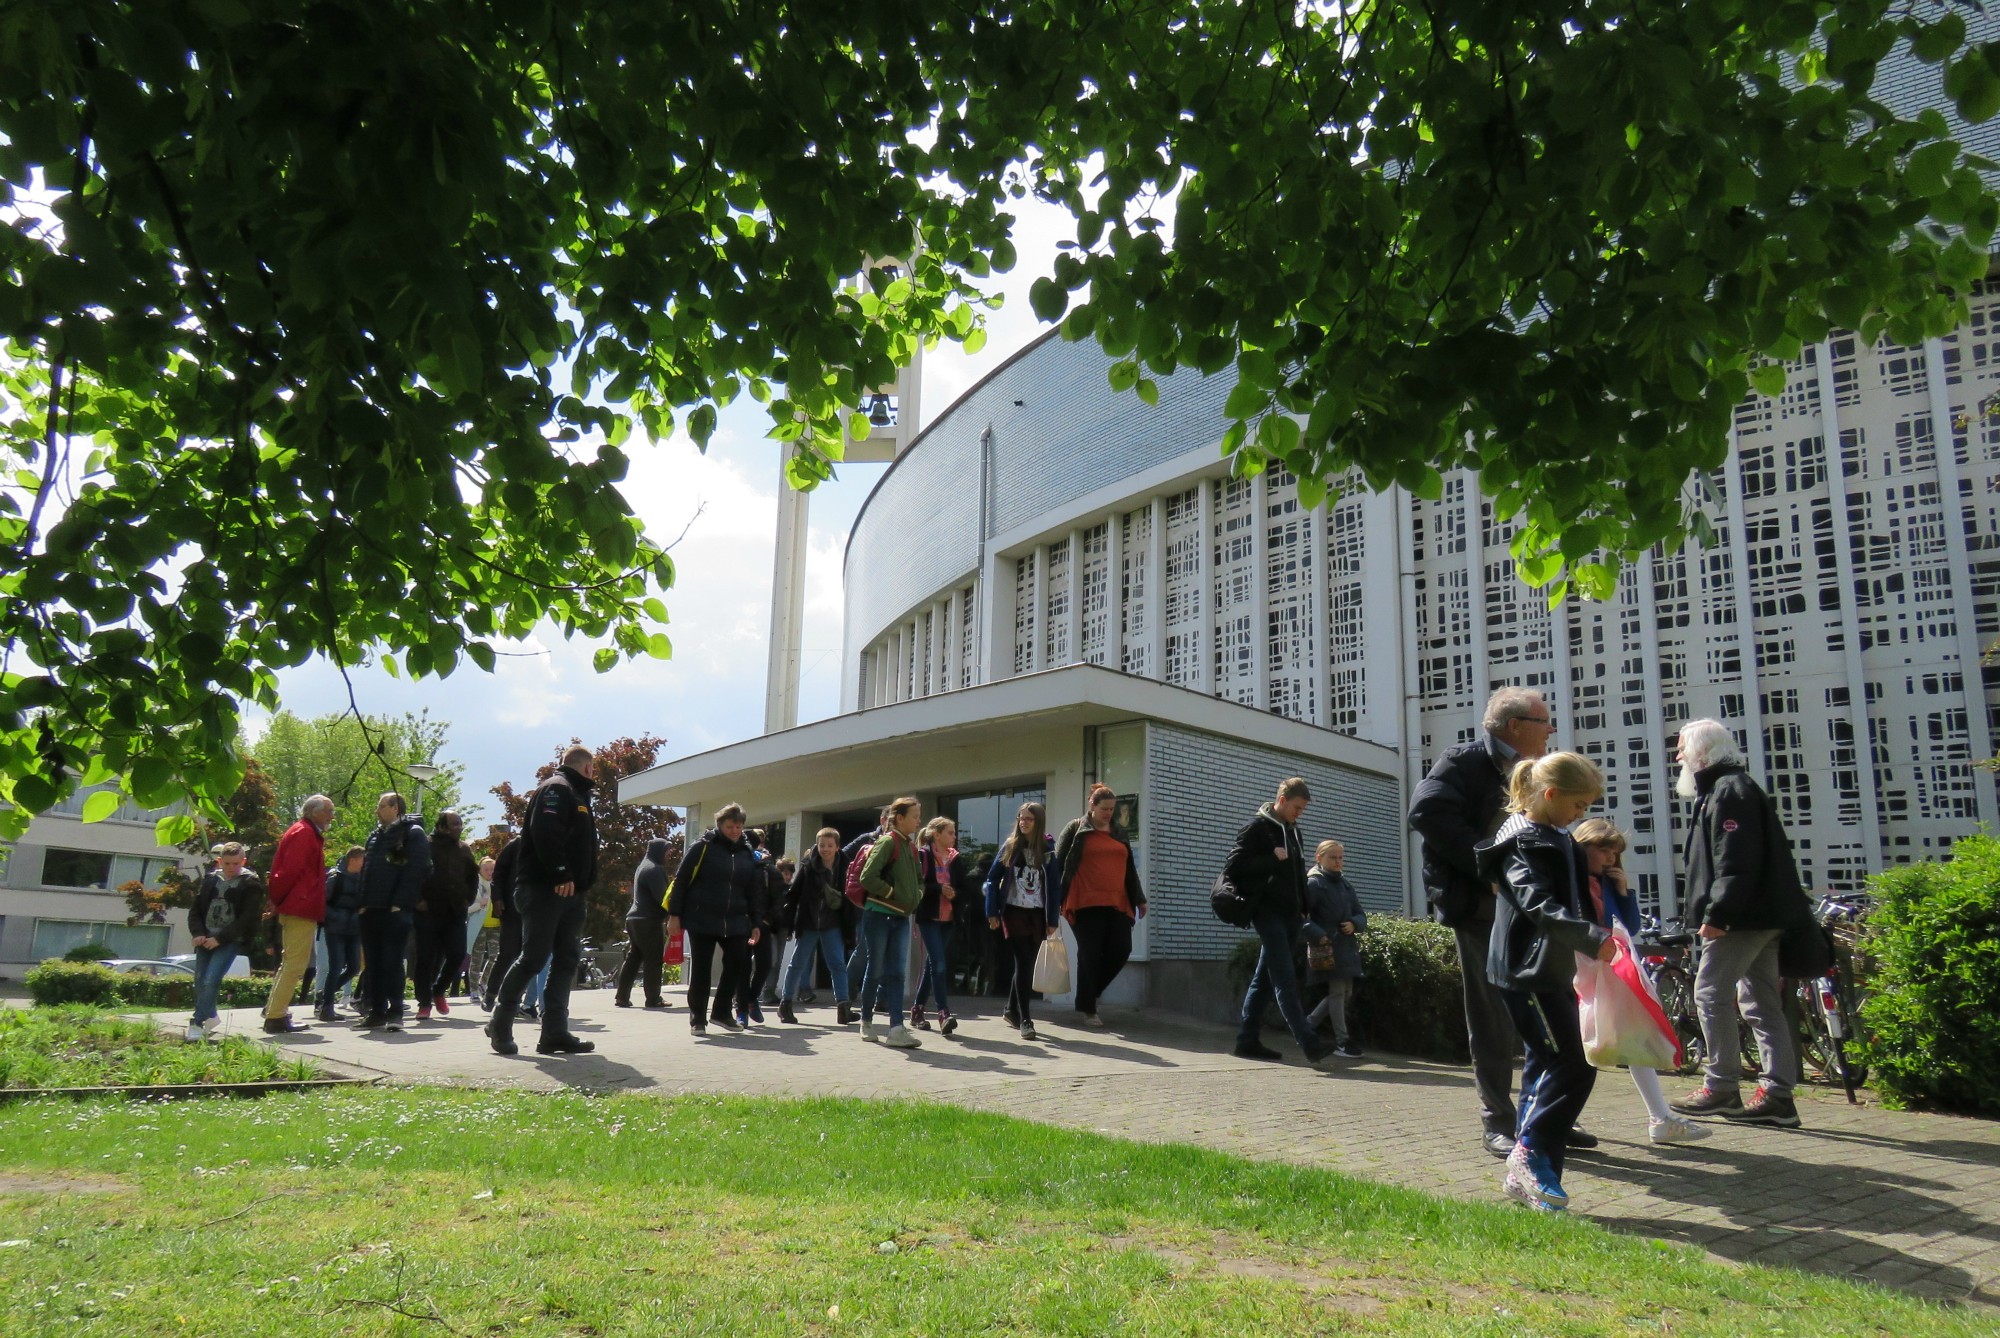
[1478,814,1610,994]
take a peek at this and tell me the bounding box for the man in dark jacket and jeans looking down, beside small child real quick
[1222,776,1332,1064]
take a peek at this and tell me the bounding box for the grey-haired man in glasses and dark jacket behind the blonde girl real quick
[1410,688,1596,1158]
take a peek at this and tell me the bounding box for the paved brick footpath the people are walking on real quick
[211,990,2000,1306]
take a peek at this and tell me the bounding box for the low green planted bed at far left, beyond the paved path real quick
[0,1004,324,1088]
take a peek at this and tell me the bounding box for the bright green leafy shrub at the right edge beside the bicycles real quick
[1862,834,2000,1116]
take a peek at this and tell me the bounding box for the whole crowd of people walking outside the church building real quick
[188,688,1810,1212]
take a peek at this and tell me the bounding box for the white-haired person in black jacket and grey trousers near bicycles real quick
[1674,720,1806,1128]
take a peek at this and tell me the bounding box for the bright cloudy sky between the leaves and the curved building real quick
[250,208,1074,818]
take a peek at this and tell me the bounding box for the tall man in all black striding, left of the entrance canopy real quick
[486,744,598,1054]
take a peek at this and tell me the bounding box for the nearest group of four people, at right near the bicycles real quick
[1410,688,1812,1212]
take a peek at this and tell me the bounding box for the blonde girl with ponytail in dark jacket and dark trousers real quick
[1476,752,1616,1212]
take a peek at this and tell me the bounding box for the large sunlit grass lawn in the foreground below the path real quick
[0,1088,1992,1338]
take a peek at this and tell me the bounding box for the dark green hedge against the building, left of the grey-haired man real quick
[1228,916,1470,1064]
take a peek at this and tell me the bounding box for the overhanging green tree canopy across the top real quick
[0,0,2000,834]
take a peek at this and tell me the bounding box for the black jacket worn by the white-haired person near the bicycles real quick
[1682,762,1808,930]
